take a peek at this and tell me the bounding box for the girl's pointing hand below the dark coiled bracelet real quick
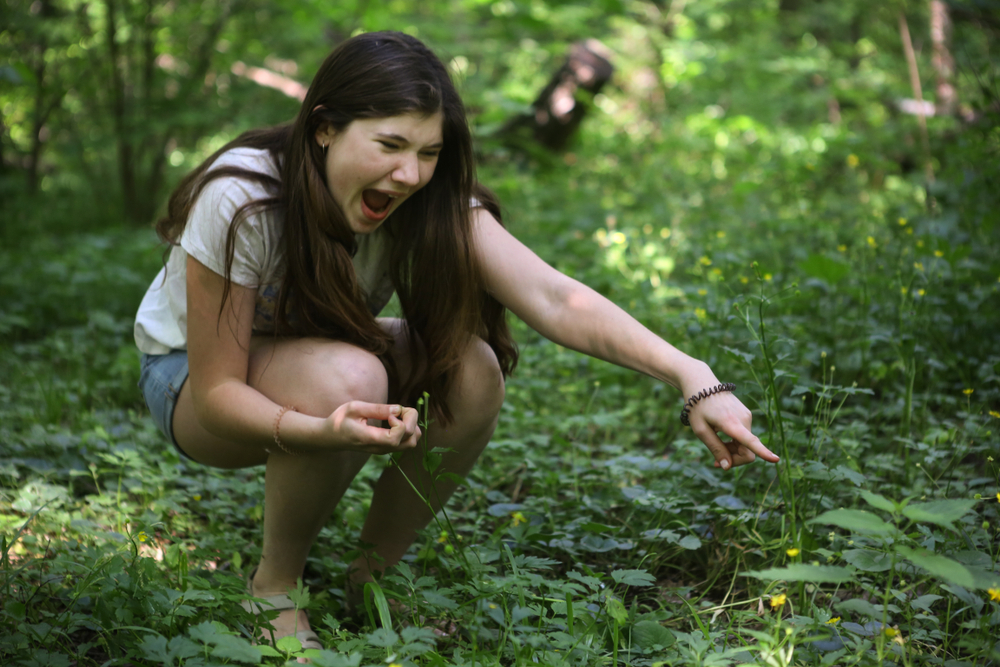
[688,385,778,470]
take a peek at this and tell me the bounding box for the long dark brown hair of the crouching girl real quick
[156,32,518,423]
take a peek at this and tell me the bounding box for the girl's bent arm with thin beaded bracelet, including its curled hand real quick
[187,256,416,453]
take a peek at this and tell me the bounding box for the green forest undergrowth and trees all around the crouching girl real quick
[0,0,1000,666]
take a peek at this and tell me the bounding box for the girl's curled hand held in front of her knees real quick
[324,401,421,454]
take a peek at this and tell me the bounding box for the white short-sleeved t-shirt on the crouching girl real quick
[134,148,393,354]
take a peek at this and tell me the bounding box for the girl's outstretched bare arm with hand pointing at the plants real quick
[474,208,778,469]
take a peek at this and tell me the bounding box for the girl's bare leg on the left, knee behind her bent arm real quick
[174,339,388,637]
